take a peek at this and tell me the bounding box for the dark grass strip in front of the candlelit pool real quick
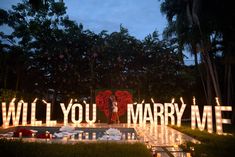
[0,139,151,157]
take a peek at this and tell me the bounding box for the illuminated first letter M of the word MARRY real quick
[127,104,143,124]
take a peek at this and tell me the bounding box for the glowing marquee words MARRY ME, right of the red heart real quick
[127,103,232,134]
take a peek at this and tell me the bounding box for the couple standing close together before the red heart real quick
[108,95,119,124]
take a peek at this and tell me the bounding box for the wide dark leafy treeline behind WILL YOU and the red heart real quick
[0,0,195,104]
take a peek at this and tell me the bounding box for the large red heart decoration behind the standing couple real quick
[96,90,132,117]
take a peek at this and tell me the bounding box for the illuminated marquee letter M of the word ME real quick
[191,105,213,133]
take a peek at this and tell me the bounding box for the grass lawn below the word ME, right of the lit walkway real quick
[171,125,235,157]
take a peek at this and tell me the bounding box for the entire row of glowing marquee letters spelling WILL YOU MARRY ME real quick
[2,98,232,134]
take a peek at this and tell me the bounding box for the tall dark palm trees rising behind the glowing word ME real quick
[161,0,235,120]
